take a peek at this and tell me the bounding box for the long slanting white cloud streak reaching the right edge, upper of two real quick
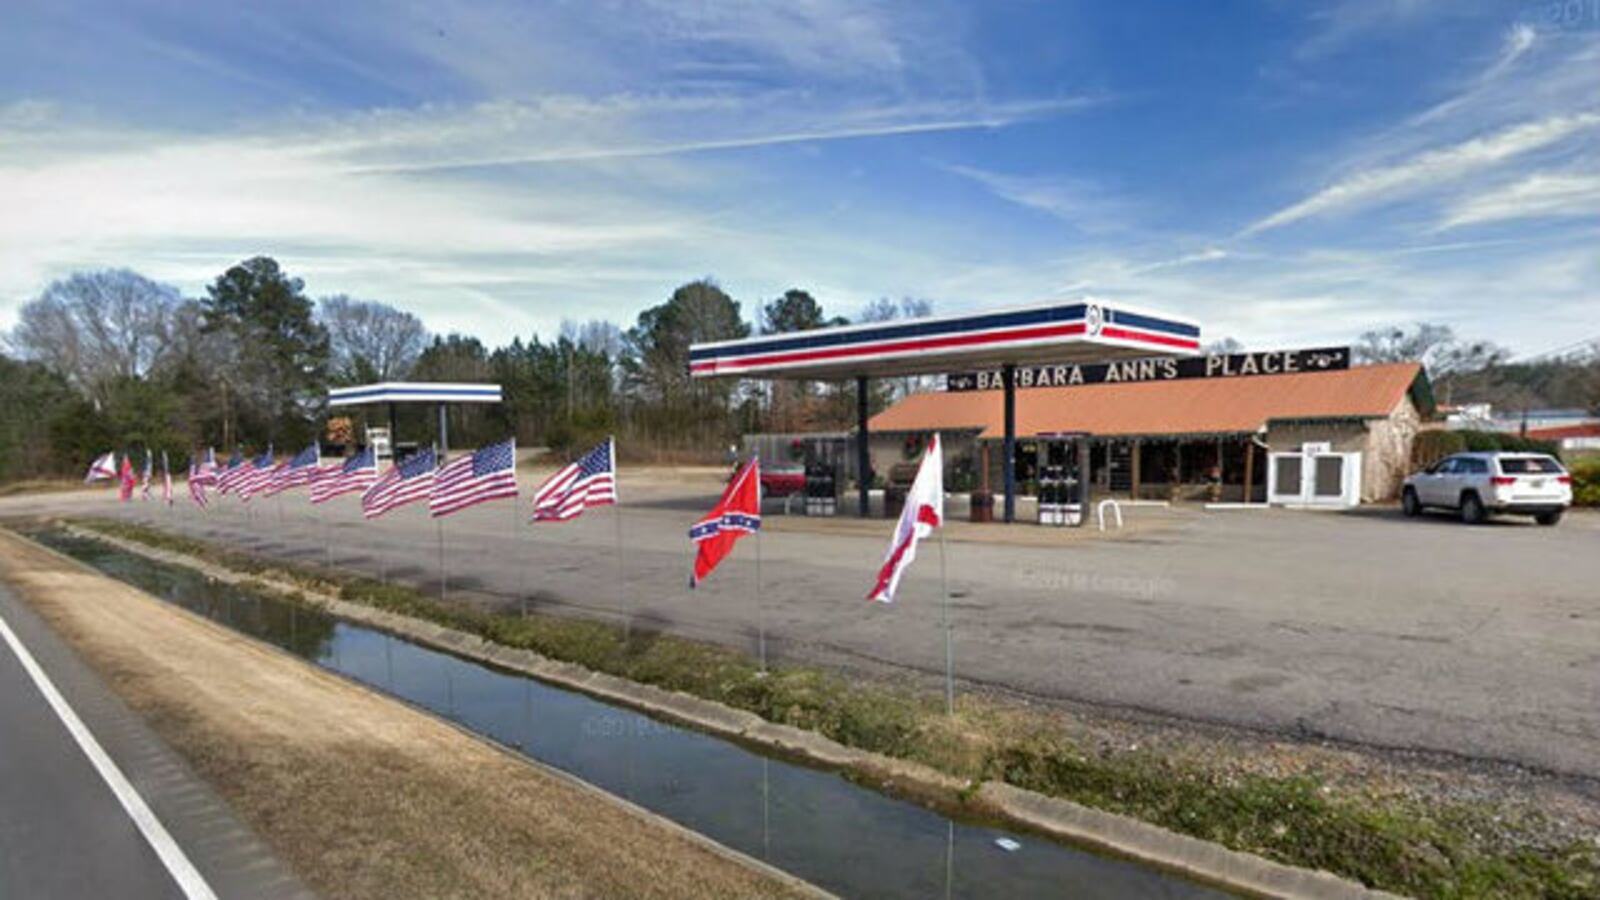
[1242,112,1600,235]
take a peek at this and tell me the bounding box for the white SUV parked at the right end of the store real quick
[1400,453,1573,525]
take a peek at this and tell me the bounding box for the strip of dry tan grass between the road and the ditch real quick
[0,536,812,898]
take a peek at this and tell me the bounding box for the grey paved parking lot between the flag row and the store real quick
[12,488,1600,777]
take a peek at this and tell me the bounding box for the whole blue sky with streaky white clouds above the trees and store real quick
[0,0,1600,354]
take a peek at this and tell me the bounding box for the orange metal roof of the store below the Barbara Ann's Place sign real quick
[867,362,1421,437]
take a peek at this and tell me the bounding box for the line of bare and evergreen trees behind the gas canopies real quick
[0,256,930,480]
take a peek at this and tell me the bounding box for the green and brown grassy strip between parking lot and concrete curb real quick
[62,520,1600,900]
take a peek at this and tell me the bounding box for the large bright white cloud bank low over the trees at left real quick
[0,83,1078,338]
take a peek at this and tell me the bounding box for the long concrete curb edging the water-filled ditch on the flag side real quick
[64,524,1398,900]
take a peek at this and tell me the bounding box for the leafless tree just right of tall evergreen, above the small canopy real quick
[317,293,429,383]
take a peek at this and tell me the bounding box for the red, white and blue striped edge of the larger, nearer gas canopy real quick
[690,299,1200,374]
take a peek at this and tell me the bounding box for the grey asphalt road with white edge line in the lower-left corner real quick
[0,576,309,900]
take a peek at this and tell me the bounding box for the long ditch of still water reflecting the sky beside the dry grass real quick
[34,532,1219,898]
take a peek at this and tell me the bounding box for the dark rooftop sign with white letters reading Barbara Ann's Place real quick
[944,348,1350,391]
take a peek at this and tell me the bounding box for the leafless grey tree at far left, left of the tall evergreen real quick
[8,269,181,400]
